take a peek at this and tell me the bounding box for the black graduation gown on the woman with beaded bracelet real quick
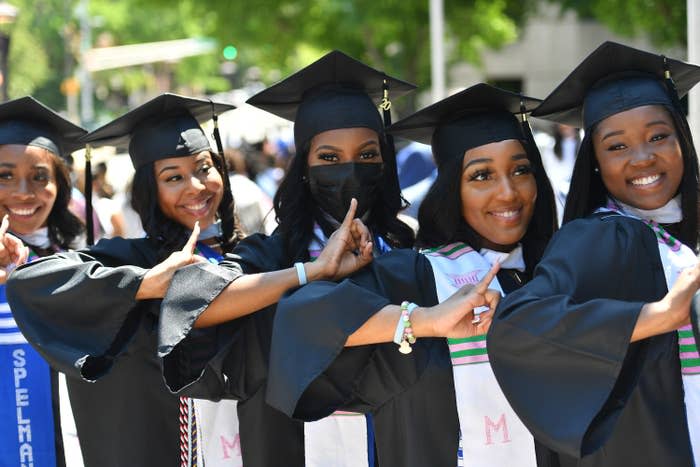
[268,250,548,467]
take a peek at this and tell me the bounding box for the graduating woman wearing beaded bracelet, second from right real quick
[268,84,556,467]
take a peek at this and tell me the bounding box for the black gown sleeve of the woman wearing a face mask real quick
[158,234,288,400]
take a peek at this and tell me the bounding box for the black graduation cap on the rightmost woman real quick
[532,42,700,129]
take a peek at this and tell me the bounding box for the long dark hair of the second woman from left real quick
[131,151,243,260]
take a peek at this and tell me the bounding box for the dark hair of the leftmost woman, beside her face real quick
[46,151,84,250]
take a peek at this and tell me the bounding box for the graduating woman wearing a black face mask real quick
[160,51,414,467]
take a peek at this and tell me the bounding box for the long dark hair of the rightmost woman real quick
[563,106,700,250]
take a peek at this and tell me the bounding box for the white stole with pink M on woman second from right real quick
[423,243,537,467]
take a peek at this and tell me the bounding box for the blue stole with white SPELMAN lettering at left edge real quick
[0,255,61,467]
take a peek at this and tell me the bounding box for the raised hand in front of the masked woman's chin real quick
[307,198,372,280]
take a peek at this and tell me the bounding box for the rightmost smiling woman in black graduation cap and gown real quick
[488,42,700,467]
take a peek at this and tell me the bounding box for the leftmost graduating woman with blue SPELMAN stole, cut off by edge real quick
[0,97,86,467]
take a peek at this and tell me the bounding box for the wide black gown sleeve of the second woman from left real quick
[7,238,156,380]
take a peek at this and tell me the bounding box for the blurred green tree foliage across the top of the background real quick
[0,0,686,117]
